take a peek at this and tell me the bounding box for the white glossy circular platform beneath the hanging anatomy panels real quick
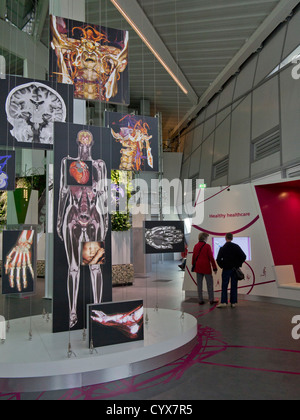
[0,308,197,393]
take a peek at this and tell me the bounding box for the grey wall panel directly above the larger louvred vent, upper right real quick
[252,76,279,139]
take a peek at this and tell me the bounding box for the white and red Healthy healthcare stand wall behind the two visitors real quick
[184,179,300,303]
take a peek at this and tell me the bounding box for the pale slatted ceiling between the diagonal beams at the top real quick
[36,0,299,141]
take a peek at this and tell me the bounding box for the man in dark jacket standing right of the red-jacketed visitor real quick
[217,233,246,308]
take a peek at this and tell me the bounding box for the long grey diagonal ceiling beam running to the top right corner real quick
[170,0,300,139]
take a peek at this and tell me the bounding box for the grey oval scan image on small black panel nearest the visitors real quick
[145,226,184,251]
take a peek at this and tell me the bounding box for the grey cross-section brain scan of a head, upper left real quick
[5,82,67,145]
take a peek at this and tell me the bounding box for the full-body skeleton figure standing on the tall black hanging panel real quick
[57,130,108,328]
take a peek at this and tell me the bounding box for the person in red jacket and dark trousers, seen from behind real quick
[192,233,218,305]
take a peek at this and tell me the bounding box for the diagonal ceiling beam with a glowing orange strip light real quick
[111,0,199,105]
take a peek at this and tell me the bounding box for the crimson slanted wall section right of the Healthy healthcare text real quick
[255,181,300,283]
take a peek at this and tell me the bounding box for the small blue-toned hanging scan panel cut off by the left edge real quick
[0,150,16,191]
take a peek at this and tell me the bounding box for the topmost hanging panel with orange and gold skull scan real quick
[50,16,130,105]
